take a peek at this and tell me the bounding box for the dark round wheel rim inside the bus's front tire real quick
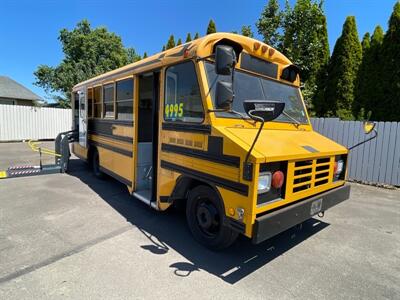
[196,198,221,237]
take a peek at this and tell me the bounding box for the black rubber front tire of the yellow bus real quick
[186,185,239,250]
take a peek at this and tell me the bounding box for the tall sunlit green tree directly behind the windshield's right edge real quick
[279,0,329,111]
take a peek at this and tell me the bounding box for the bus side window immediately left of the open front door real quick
[116,78,133,120]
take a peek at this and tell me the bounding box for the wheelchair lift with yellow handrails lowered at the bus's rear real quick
[0,131,78,179]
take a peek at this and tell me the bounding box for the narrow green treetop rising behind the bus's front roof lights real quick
[256,0,283,48]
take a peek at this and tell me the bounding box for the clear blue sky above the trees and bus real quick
[0,0,396,101]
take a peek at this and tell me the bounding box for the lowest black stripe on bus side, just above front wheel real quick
[161,160,249,196]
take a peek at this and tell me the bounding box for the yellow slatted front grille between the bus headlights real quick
[289,157,334,194]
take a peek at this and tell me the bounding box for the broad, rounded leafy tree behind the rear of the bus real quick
[34,20,134,105]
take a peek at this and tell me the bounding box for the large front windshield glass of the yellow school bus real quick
[205,62,308,124]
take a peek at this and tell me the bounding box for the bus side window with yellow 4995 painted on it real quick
[164,61,204,123]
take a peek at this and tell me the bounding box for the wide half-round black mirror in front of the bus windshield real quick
[243,100,285,122]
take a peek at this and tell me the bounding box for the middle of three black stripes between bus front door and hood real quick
[161,144,240,168]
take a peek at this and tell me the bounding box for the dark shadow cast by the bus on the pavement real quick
[69,160,329,284]
